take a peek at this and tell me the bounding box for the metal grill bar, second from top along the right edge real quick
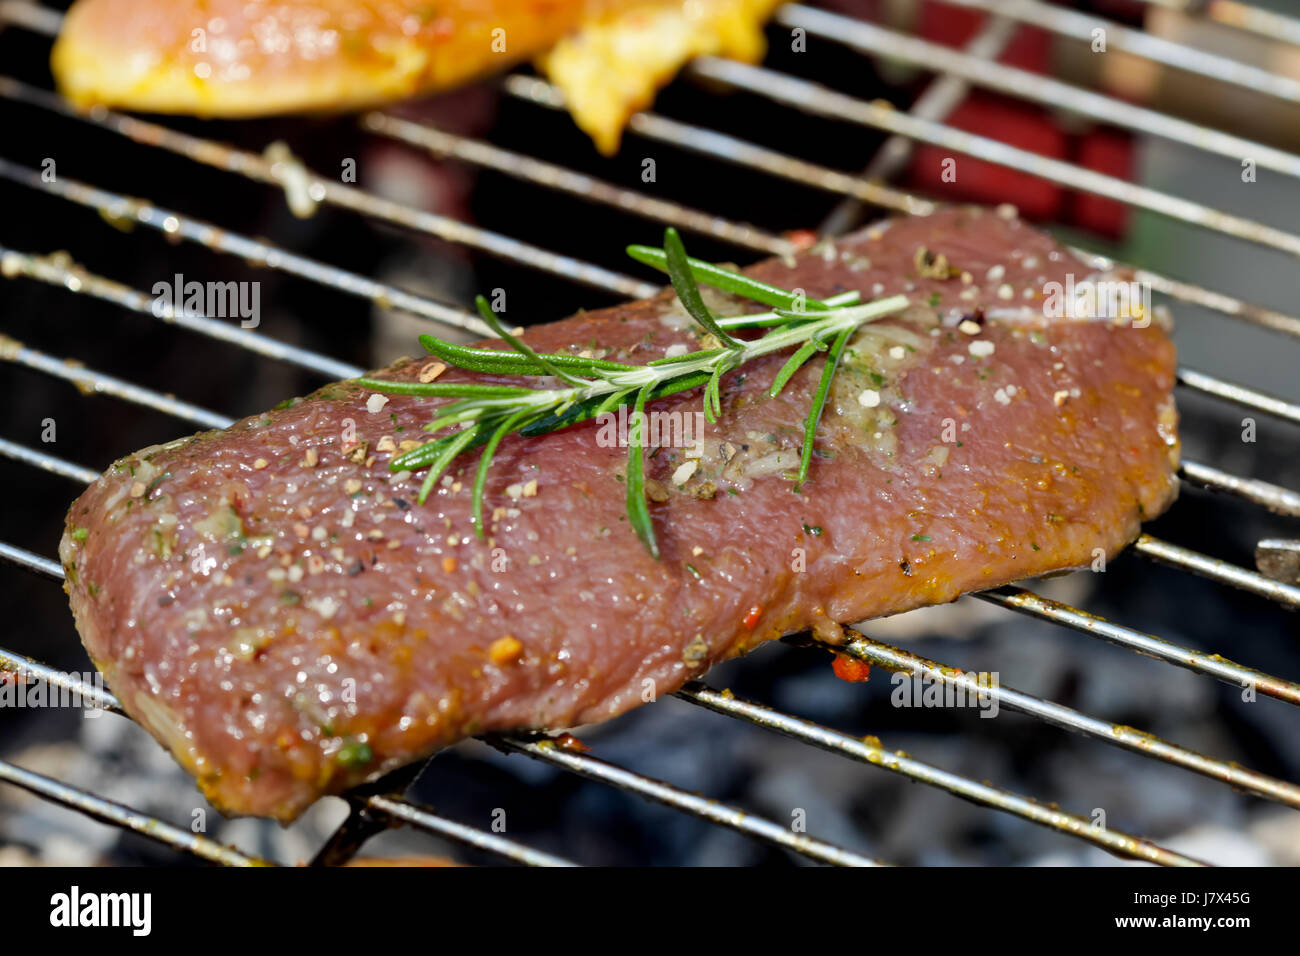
[944,0,1300,103]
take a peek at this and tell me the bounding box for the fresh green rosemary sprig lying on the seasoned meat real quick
[358,229,907,558]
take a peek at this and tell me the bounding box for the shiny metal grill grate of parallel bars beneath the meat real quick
[0,0,1300,865]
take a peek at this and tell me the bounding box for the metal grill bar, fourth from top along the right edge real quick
[686,57,1300,256]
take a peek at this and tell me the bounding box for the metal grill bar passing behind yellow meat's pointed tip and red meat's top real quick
[503,75,1300,337]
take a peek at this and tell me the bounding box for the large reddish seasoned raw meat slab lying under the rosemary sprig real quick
[60,209,1178,821]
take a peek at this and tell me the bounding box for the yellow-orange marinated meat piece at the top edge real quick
[52,0,776,152]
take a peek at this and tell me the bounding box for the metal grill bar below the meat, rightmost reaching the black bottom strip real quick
[679,681,1206,866]
